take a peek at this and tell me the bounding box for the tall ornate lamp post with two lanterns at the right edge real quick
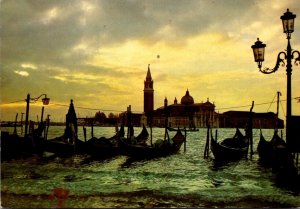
[251,9,300,148]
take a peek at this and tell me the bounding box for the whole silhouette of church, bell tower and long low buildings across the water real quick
[119,64,284,129]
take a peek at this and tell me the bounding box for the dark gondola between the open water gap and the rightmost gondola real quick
[210,128,249,161]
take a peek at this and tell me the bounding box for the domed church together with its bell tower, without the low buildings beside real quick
[140,64,218,128]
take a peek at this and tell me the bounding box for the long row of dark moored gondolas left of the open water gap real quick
[1,100,186,159]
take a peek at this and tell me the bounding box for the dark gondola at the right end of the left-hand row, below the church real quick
[120,129,186,159]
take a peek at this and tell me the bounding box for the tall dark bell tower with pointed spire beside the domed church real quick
[144,64,154,114]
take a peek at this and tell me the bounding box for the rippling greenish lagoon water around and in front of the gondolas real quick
[1,126,300,208]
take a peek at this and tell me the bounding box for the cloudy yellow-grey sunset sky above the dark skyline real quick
[0,0,300,122]
